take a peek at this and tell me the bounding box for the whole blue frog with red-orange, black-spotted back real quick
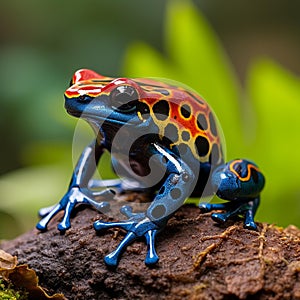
[37,69,265,266]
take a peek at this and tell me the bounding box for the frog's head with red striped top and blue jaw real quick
[65,69,151,132]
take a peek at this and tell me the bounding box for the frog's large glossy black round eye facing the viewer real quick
[110,85,138,112]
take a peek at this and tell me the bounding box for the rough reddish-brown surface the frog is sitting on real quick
[1,202,300,300]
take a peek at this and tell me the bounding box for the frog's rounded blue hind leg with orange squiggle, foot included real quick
[199,159,265,230]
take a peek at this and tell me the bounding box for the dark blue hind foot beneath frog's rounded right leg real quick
[199,198,259,230]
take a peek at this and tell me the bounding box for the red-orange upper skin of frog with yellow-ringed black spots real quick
[65,70,224,166]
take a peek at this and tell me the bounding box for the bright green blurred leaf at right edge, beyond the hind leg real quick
[248,59,300,225]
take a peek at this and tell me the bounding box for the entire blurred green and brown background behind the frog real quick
[0,0,300,238]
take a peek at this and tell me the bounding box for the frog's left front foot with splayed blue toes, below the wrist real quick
[36,187,114,232]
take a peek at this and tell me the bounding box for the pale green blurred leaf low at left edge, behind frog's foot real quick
[0,165,71,233]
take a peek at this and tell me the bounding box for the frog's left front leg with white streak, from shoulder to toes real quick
[36,142,114,231]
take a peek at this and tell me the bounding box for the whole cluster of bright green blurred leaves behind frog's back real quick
[125,1,300,225]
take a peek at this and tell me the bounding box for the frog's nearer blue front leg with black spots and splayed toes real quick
[94,144,194,267]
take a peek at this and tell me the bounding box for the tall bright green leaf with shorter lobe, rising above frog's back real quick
[124,1,243,157]
